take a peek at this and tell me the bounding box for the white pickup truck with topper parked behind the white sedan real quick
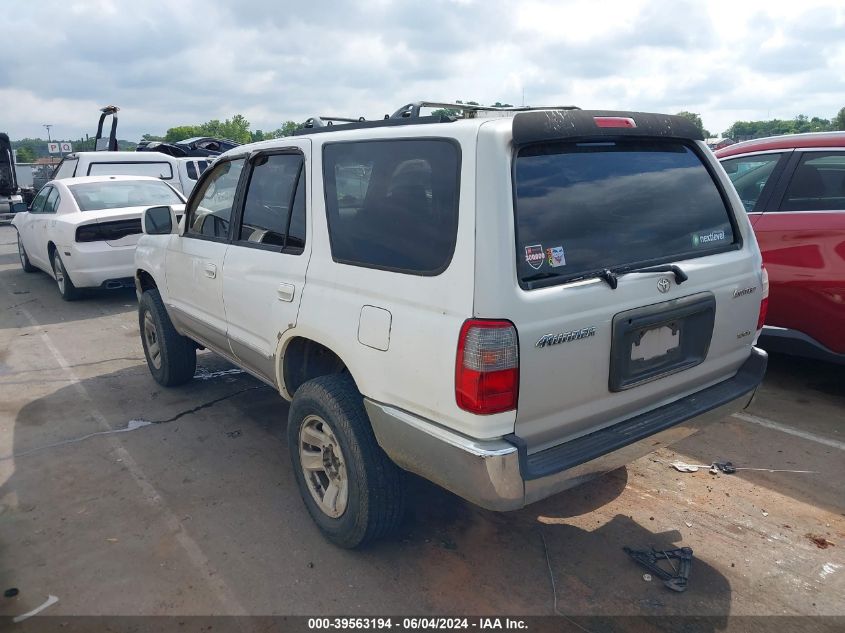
[53,151,209,195]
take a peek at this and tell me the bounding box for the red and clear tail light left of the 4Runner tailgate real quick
[455,319,519,415]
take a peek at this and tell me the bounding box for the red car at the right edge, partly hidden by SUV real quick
[716,132,845,363]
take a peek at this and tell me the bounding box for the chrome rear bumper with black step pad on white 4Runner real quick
[364,348,768,510]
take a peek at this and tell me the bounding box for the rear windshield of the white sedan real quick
[68,180,182,211]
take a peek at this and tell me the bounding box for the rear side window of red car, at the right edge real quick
[780,152,845,211]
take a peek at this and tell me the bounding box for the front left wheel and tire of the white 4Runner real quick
[138,290,197,387]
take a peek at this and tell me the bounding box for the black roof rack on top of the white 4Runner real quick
[293,101,581,136]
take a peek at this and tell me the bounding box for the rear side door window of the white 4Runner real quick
[239,154,305,249]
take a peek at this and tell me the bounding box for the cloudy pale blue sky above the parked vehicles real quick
[0,0,845,140]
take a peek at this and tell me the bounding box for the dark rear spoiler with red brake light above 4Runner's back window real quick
[513,110,704,145]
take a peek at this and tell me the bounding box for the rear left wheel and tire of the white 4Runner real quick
[287,374,405,549]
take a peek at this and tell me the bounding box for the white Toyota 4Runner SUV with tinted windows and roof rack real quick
[130,104,767,547]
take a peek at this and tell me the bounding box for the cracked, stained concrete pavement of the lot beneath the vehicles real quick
[0,227,845,630]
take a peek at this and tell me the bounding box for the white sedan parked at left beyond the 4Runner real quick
[12,176,185,301]
